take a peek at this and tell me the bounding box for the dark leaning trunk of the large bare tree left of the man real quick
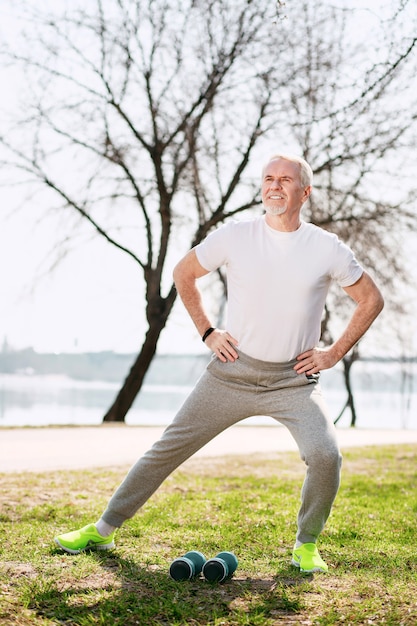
[103,289,176,422]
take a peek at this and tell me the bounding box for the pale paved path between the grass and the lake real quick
[0,424,417,472]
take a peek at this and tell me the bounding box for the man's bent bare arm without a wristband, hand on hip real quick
[294,272,384,374]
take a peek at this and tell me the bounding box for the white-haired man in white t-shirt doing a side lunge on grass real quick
[55,155,383,573]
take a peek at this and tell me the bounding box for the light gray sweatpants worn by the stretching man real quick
[102,353,341,543]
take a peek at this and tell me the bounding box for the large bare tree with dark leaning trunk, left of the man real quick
[1,0,288,421]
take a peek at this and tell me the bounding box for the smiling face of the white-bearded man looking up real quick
[261,159,311,215]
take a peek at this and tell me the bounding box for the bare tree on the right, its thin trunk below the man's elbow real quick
[288,2,417,426]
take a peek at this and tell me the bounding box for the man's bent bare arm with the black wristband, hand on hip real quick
[174,250,238,362]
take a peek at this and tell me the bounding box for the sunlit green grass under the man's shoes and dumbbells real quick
[0,445,417,626]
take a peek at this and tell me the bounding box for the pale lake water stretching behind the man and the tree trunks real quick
[0,362,417,429]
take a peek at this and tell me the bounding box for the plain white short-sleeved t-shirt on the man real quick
[195,215,363,363]
